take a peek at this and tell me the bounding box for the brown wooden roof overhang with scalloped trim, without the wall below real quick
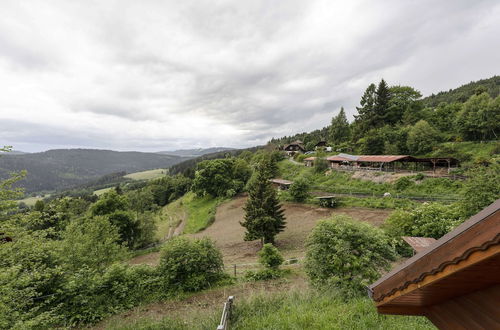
[369,199,500,315]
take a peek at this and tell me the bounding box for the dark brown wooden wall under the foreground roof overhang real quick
[425,284,500,330]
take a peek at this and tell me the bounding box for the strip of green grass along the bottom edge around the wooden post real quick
[102,281,435,330]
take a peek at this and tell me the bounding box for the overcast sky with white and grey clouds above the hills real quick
[0,0,500,151]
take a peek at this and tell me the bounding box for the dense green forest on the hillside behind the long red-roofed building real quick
[269,76,500,158]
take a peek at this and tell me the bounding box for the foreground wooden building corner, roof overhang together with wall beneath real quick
[368,199,500,329]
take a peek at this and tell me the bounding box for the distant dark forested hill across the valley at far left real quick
[0,149,187,192]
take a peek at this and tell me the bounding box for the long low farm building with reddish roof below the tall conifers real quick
[327,154,459,172]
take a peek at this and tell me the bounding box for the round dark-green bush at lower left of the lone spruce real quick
[158,237,224,291]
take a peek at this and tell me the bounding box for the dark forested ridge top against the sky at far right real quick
[422,76,500,107]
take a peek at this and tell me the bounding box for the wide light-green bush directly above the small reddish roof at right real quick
[384,203,462,239]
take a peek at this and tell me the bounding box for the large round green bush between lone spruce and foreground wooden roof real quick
[305,215,396,295]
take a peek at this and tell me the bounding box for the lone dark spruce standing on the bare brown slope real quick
[240,165,286,245]
